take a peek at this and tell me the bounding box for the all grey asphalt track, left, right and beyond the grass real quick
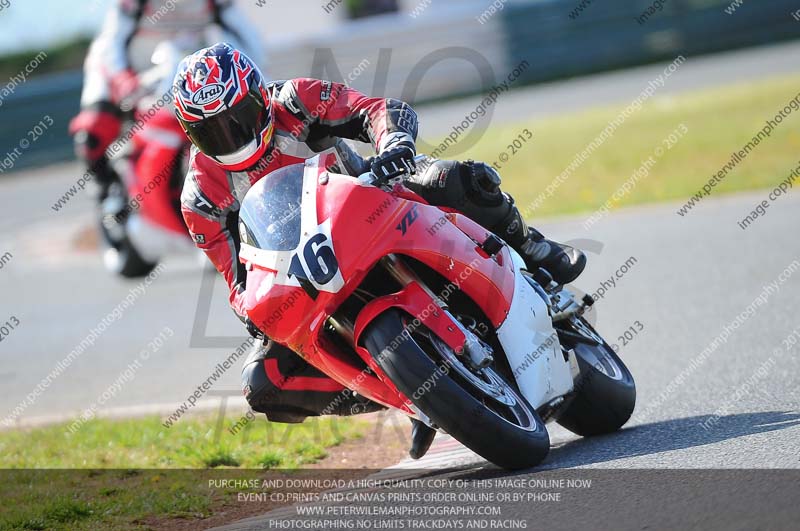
[0,40,800,482]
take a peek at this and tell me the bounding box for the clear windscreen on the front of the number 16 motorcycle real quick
[239,164,304,251]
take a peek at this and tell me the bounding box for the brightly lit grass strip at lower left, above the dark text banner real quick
[0,415,363,469]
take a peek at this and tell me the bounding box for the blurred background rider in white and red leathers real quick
[69,0,262,199]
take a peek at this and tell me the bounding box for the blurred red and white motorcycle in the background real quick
[98,41,195,277]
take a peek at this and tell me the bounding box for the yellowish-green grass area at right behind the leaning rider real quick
[456,76,800,217]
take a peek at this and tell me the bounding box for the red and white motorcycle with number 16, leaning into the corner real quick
[239,153,636,469]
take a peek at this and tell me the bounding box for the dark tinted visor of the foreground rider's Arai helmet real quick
[184,82,270,156]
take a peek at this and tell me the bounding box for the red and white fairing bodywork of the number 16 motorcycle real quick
[240,154,569,415]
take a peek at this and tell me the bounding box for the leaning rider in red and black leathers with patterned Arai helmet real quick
[175,43,586,458]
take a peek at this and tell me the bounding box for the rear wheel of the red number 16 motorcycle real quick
[557,317,636,436]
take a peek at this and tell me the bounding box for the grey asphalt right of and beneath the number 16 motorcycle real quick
[215,186,800,531]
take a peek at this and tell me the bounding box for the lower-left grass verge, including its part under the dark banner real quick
[0,415,366,531]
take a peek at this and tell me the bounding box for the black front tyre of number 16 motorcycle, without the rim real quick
[362,310,550,470]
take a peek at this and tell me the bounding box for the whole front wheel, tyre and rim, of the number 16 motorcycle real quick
[363,310,550,470]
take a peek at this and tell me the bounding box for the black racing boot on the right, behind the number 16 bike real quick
[492,195,586,284]
